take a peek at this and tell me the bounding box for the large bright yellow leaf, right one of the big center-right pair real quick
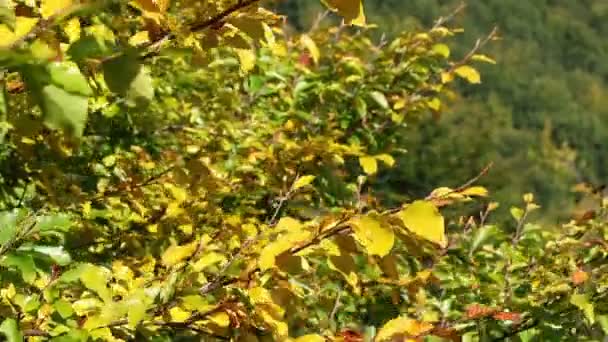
[398,201,447,247]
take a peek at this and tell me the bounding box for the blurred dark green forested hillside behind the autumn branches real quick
[281,0,608,222]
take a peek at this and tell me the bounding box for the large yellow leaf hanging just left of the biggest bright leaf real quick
[351,216,395,256]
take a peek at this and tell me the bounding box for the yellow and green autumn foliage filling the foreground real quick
[0,0,607,342]
